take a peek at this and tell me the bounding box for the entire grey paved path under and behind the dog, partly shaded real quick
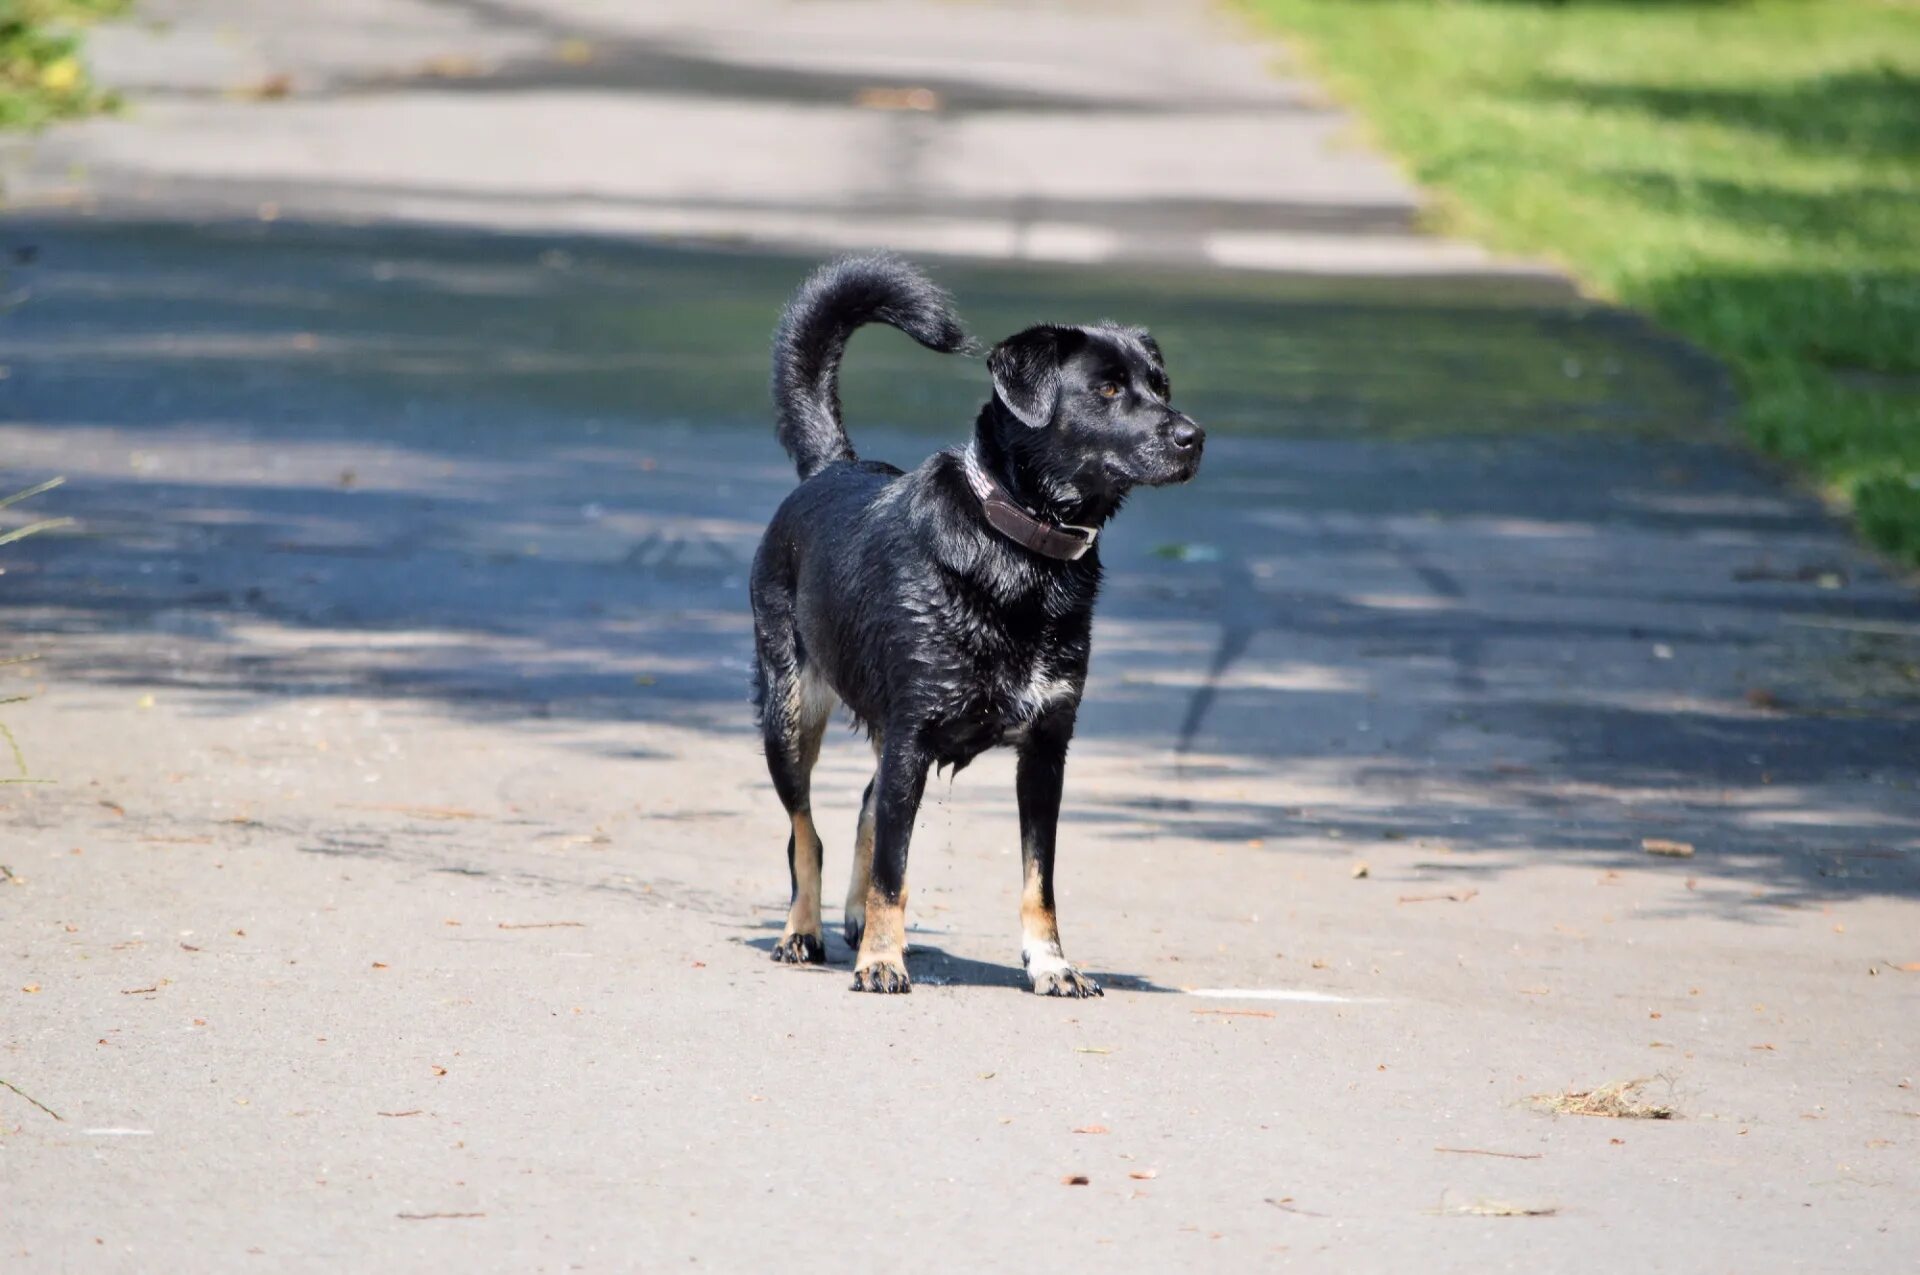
[0,0,1920,1271]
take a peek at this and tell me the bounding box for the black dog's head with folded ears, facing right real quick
[987,325,1206,509]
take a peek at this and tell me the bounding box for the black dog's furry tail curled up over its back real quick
[774,253,970,478]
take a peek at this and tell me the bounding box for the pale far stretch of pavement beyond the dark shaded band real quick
[12,0,1524,273]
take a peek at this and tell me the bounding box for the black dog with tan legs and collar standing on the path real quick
[753,255,1204,997]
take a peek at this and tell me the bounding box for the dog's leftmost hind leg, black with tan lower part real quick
[762,664,833,966]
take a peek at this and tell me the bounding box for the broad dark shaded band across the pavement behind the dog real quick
[0,223,1920,917]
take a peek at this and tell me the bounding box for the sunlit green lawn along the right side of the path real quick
[1240,0,1920,563]
